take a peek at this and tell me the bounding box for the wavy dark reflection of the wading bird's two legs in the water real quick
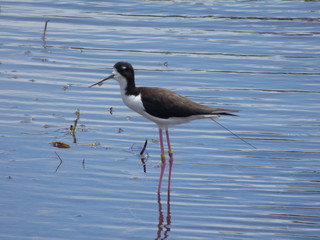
[155,192,171,240]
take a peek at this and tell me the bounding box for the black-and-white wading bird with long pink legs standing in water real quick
[89,62,238,194]
